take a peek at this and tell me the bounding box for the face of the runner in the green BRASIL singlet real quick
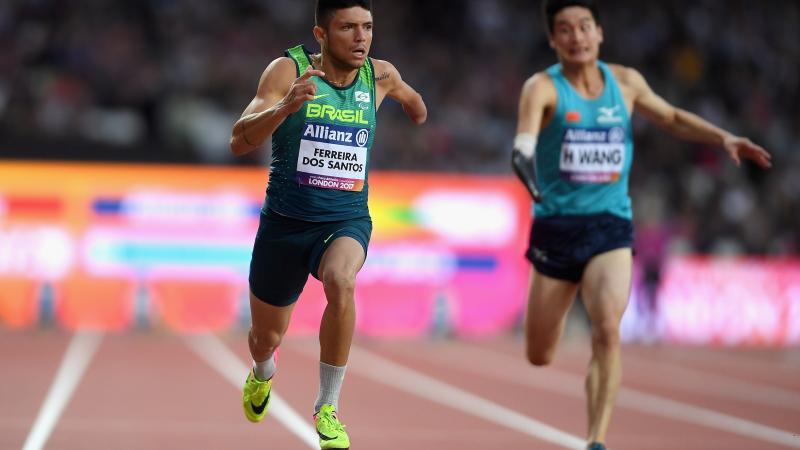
[314,6,372,69]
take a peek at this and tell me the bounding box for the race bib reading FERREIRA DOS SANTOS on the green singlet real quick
[297,122,369,192]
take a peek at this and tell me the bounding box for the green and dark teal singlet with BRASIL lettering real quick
[264,45,375,222]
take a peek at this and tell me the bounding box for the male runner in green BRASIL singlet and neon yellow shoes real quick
[231,0,427,449]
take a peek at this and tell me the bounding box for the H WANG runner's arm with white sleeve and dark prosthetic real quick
[511,73,556,201]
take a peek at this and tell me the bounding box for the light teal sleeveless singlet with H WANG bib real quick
[534,62,633,219]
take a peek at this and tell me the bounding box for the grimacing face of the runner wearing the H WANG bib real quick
[550,6,603,64]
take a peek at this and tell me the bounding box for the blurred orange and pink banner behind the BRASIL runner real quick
[0,162,530,336]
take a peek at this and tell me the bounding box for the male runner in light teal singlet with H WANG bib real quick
[512,0,770,450]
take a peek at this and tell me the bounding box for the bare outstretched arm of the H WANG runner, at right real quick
[624,68,772,168]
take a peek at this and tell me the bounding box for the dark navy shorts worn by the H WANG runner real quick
[525,214,633,283]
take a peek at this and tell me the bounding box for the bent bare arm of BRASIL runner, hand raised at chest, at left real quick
[230,57,325,156]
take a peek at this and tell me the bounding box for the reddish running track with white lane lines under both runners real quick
[0,329,800,450]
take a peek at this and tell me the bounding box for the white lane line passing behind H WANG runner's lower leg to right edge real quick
[448,345,800,448]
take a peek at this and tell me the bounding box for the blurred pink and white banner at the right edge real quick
[658,257,800,346]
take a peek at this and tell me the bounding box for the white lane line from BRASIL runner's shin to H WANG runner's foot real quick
[348,346,586,450]
